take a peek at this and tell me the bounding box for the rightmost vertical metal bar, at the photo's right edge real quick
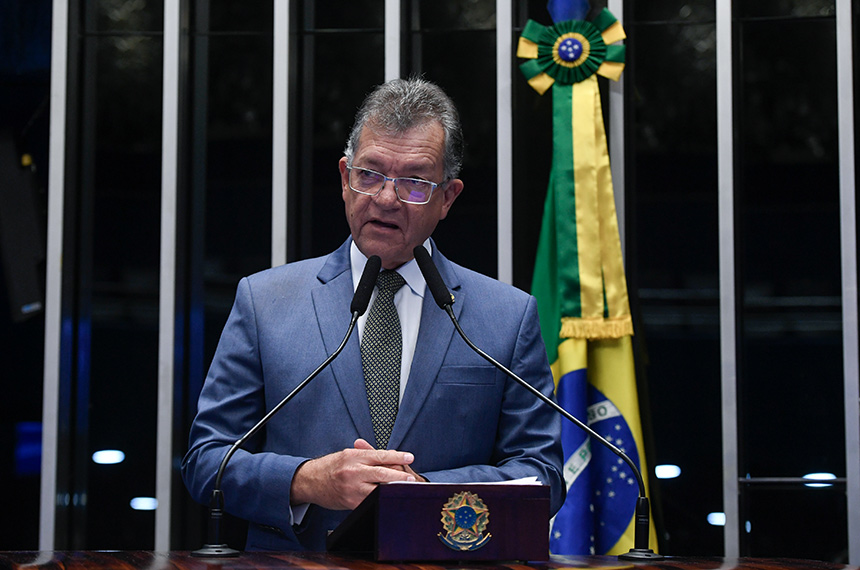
[836,0,860,566]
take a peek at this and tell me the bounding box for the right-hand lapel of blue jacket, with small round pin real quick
[388,243,466,451]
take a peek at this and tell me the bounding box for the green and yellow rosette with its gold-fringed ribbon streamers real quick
[517,9,633,339]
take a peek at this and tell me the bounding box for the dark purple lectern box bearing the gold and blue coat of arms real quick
[327,483,549,562]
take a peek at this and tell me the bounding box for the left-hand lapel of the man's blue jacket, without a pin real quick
[311,239,374,442]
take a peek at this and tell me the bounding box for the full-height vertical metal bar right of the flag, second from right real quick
[716,0,740,558]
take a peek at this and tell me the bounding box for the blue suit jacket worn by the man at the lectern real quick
[182,236,565,550]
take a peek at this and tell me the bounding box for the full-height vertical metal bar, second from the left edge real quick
[155,0,180,551]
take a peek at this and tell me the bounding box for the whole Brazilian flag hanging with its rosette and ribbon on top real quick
[517,5,655,554]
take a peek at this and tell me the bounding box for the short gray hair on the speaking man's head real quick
[343,78,463,180]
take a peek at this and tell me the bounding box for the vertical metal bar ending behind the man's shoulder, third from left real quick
[272,0,290,267]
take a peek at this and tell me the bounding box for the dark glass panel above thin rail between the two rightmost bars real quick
[737,20,844,477]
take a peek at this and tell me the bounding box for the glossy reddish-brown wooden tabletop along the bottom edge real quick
[0,550,857,570]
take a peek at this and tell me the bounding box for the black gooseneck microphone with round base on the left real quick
[197,255,382,558]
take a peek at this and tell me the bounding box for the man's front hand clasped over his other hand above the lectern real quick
[290,439,419,510]
